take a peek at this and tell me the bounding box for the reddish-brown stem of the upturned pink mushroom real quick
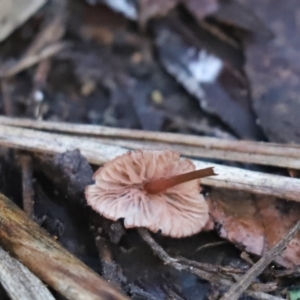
[144,168,217,194]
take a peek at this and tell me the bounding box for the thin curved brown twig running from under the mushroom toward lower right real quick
[138,228,283,300]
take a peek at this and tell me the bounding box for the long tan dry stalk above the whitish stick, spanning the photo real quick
[0,117,300,169]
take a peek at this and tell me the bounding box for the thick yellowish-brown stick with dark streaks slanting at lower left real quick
[0,194,128,300]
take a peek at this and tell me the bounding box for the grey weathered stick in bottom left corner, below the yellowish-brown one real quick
[0,247,55,300]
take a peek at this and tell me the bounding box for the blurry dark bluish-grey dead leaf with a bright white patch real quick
[155,19,262,139]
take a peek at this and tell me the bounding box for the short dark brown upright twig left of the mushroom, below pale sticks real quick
[19,154,34,219]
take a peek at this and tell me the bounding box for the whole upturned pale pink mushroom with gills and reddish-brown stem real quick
[85,150,216,238]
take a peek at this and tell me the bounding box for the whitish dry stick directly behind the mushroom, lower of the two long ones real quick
[0,125,300,201]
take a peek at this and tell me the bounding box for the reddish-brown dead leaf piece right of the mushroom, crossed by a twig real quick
[208,189,300,268]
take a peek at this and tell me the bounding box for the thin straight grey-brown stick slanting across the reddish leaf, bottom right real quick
[220,221,300,300]
